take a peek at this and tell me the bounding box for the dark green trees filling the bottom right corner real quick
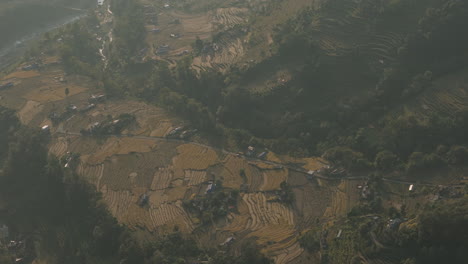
[336,184,468,264]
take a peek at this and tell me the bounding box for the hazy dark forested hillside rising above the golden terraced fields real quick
[93,0,468,169]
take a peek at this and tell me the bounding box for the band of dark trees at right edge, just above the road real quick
[324,108,468,172]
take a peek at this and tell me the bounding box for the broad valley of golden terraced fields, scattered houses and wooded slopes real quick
[0,0,468,264]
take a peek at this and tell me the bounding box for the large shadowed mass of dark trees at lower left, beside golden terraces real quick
[0,109,124,263]
